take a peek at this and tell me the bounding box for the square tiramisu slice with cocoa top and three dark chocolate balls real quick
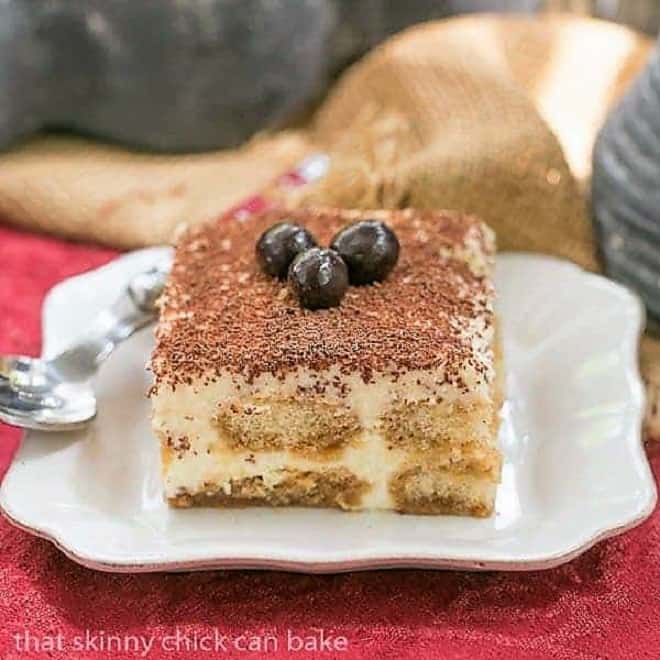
[151,209,502,516]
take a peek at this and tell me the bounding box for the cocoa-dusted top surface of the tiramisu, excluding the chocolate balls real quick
[151,209,494,388]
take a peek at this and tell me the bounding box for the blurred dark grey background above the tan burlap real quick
[0,0,660,151]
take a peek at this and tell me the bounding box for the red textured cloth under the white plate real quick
[0,227,660,660]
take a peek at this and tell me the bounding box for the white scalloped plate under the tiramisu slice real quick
[0,249,656,572]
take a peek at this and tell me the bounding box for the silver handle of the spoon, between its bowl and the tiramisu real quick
[49,265,168,382]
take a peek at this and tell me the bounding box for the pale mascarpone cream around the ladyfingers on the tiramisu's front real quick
[152,368,493,509]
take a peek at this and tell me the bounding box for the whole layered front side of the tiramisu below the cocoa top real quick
[153,356,501,515]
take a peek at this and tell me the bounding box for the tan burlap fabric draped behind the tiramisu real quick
[0,16,660,436]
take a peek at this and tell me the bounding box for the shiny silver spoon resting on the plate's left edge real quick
[0,264,168,431]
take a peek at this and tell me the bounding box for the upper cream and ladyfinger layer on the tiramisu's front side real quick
[152,369,499,472]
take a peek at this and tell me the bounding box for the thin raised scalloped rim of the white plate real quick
[0,247,657,573]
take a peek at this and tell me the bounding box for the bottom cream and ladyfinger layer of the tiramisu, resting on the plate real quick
[164,432,499,515]
